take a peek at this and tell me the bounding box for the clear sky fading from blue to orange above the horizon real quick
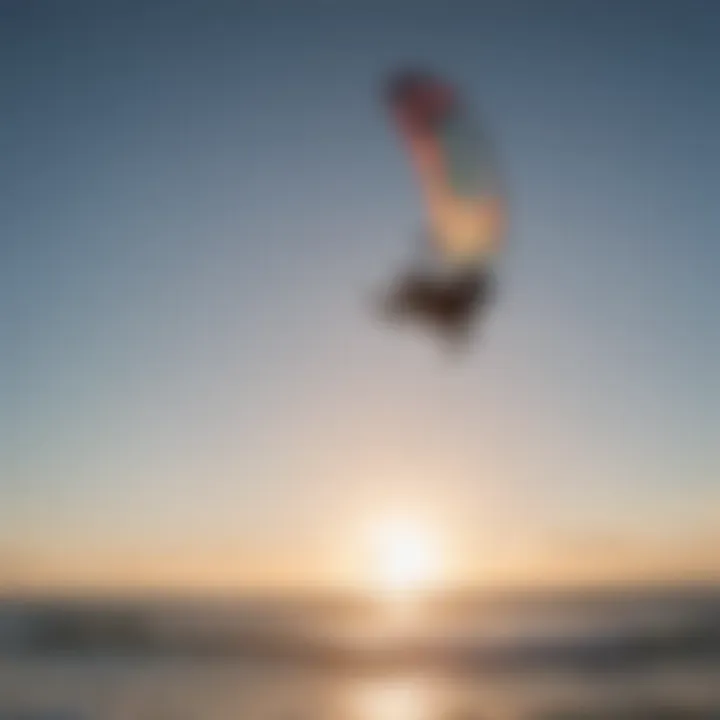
[0,0,720,588]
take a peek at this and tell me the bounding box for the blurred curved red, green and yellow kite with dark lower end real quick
[381,71,507,343]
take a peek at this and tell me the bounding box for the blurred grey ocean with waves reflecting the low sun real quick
[0,589,720,720]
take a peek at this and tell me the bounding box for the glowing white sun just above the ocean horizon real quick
[371,518,441,596]
